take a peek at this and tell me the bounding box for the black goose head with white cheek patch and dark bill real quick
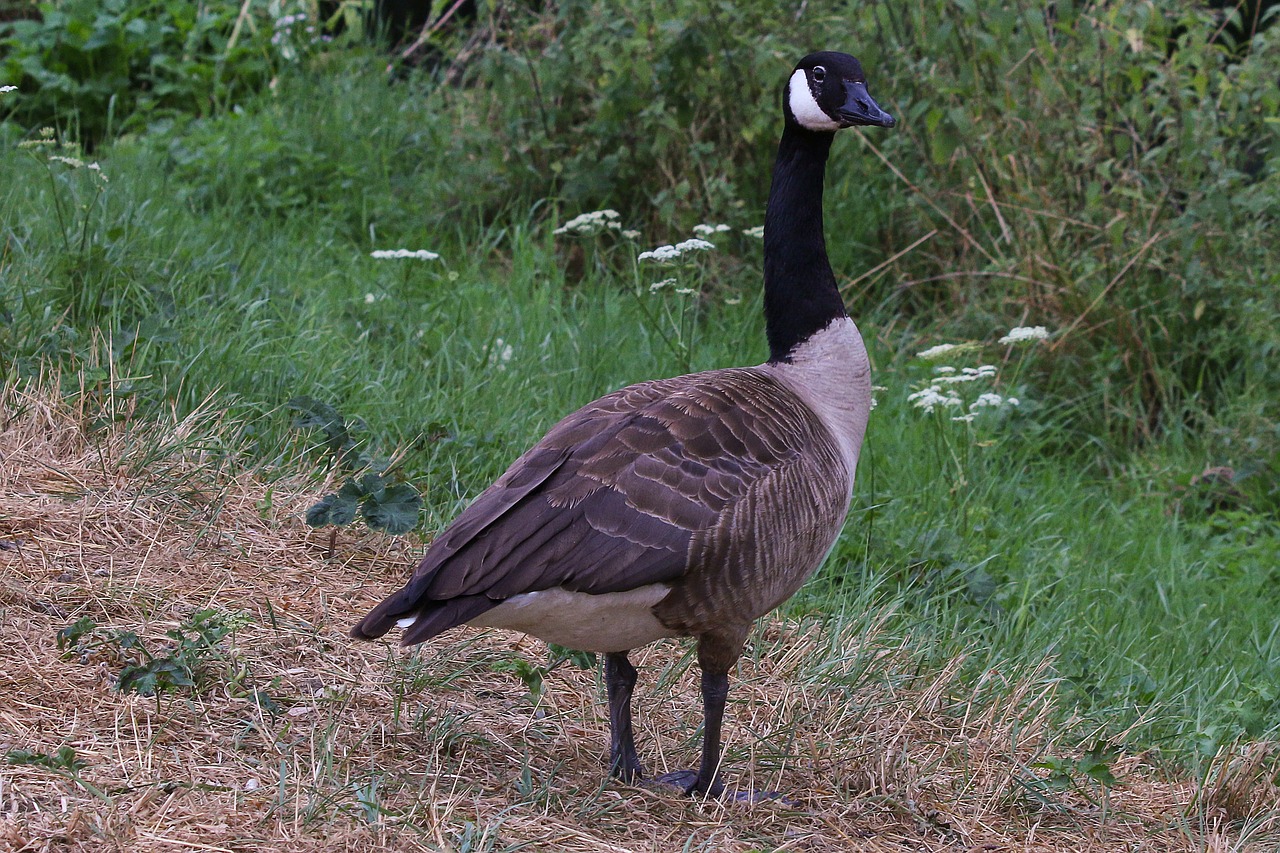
[782,50,895,133]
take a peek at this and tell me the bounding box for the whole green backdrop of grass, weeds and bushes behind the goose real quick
[0,0,1280,845]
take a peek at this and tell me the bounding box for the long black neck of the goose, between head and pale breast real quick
[764,122,845,361]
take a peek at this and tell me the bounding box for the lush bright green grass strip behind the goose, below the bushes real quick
[0,54,1280,762]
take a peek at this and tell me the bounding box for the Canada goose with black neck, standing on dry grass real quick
[352,51,893,797]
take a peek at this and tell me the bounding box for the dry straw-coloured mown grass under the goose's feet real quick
[0,383,1280,852]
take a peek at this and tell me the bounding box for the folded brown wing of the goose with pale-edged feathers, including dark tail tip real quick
[352,369,849,644]
